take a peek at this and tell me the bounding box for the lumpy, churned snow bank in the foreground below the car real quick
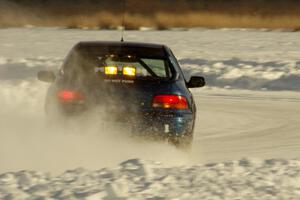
[0,159,300,200]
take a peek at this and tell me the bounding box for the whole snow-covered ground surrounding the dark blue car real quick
[0,28,300,200]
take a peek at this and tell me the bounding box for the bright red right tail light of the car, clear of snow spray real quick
[152,95,188,110]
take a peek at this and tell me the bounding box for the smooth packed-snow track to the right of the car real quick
[192,91,300,162]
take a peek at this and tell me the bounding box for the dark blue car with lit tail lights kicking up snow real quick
[38,41,205,146]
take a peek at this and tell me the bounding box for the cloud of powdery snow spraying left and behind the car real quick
[0,58,188,173]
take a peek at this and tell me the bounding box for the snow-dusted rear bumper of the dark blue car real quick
[56,105,194,137]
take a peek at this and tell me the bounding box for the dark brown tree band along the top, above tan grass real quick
[0,0,300,15]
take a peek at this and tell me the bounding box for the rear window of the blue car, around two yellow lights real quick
[63,46,172,79]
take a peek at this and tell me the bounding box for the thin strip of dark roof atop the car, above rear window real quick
[75,41,166,49]
